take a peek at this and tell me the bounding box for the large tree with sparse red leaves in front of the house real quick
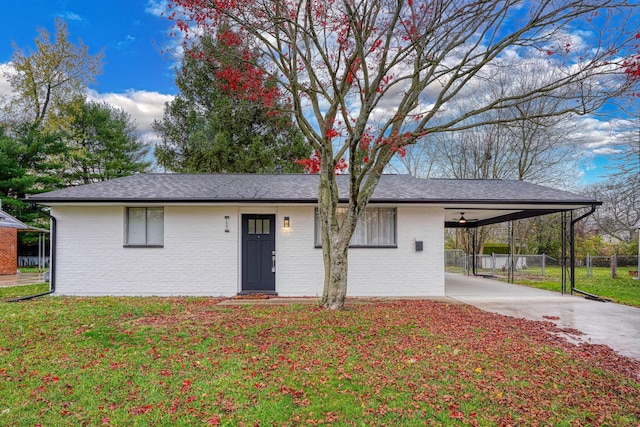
[172,0,640,309]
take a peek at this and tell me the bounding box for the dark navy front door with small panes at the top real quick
[242,214,276,294]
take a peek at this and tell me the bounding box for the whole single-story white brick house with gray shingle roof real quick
[29,174,598,296]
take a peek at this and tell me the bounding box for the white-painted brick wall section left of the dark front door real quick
[52,206,238,296]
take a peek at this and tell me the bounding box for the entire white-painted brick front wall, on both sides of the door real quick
[53,205,444,296]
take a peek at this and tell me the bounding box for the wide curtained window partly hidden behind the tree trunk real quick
[315,208,397,248]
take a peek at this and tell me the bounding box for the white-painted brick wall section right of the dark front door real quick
[276,205,444,297]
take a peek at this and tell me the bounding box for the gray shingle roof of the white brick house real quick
[29,174,599,205]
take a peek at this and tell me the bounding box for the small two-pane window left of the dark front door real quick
[125,208,164,247]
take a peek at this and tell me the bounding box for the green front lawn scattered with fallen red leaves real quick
[0,297,640,426]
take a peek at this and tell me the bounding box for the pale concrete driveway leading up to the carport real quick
[445,273,640,360]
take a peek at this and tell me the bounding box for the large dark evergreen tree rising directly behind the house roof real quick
[154,31,310,173]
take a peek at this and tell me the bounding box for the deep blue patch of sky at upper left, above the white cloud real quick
[0,0,176,94]
